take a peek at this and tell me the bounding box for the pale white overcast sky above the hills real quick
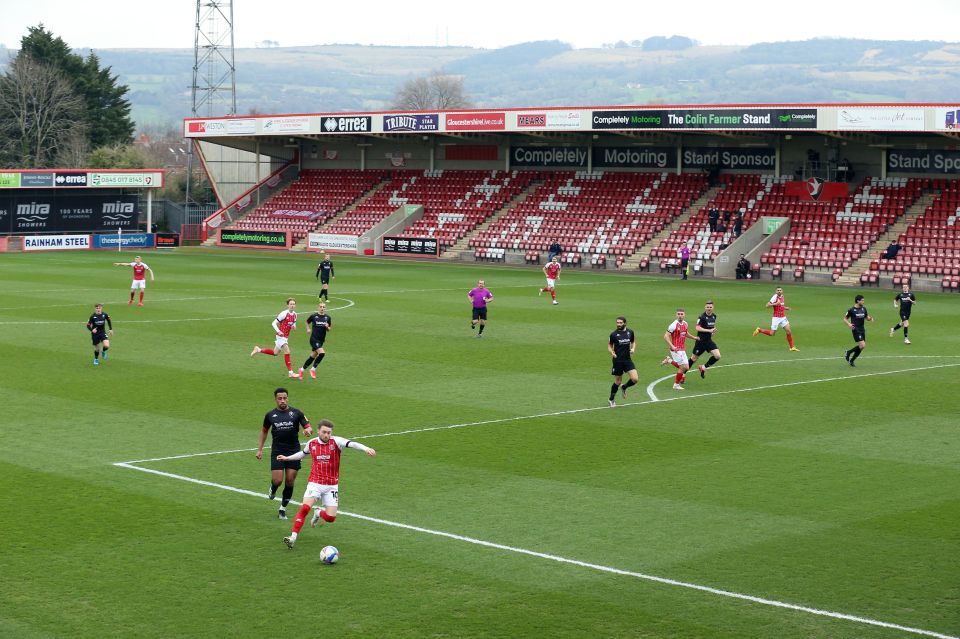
[0,0,960,49]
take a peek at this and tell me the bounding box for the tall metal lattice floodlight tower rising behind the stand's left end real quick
[186,0,237,210]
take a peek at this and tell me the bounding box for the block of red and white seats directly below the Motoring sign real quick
[469,171,706,268]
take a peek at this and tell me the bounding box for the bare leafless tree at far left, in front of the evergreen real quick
[0,53,87,168]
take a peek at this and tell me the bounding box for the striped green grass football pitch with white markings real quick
[0,249,960,639]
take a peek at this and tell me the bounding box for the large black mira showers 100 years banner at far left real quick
[0,198,140,233]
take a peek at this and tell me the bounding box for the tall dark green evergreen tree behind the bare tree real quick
[17,24,134,148]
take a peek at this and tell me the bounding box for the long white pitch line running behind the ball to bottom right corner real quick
[113,462,960,639]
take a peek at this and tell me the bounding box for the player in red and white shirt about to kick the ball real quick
[277,419,377,550]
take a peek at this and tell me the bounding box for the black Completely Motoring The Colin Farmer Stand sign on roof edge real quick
[591,108,817,131]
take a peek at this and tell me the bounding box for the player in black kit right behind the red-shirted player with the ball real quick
[257,388,313,519]
